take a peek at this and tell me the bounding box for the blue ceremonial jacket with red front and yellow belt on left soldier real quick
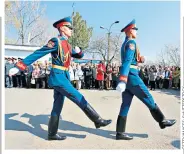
[16,36,84,87]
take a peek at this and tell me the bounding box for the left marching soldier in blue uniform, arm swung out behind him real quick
[10,17,111,140]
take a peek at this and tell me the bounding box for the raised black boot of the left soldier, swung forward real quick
[83,104,112,128]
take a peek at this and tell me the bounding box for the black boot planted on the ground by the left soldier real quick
[48,116,66,140]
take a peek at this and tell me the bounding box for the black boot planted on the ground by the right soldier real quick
[116,116,133,140]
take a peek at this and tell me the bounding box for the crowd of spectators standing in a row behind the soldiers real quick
[5,58,180,90]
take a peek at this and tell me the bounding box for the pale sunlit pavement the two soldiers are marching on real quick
[5,88,180,149]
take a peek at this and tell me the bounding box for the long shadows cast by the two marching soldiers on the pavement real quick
[5,113,148,140]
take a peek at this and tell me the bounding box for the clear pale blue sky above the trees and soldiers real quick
[6,1,180,61]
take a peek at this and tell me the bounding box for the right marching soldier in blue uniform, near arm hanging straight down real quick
[116,20,176,140]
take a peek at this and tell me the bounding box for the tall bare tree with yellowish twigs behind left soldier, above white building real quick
[5,1,51,45]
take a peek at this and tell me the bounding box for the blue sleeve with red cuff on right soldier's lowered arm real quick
[119,40,136,83]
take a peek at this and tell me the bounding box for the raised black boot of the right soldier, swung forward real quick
[150,105,176,129]
